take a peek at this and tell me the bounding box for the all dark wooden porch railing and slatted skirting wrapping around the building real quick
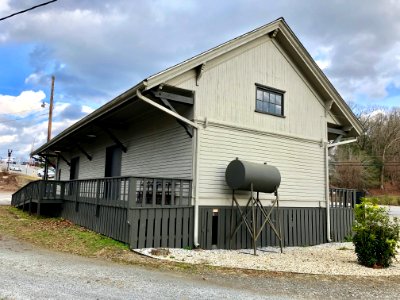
[11,177,357,249]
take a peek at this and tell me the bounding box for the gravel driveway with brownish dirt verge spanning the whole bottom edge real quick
[0,236,400,299]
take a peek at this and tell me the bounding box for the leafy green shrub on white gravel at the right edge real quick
[353,199,400,268]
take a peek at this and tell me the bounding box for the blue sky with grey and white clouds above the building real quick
[0,0,400,160]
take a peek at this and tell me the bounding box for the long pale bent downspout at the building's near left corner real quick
[136,89,200,248]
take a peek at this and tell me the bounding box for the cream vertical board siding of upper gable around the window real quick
[169,37,337,139]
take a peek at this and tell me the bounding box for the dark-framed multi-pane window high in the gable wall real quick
[256,85,285,117]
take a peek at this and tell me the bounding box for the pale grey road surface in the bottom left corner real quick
[0,237,285,299]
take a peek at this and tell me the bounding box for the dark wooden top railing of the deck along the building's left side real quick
[11,176,192,207]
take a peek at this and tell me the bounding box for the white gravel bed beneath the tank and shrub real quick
[135,243,400,276]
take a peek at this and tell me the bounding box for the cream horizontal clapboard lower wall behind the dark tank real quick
[198,125,325,207]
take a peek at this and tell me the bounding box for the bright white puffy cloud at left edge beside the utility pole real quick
[0,91,46,116]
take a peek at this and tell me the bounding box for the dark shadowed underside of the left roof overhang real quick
[31,82,194,156]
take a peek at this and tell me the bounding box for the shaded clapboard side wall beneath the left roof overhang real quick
[59,112,193,180]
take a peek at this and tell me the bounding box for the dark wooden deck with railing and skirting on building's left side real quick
[11,177,194,248]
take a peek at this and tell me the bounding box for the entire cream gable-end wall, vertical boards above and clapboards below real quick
[169,36,337,207]
